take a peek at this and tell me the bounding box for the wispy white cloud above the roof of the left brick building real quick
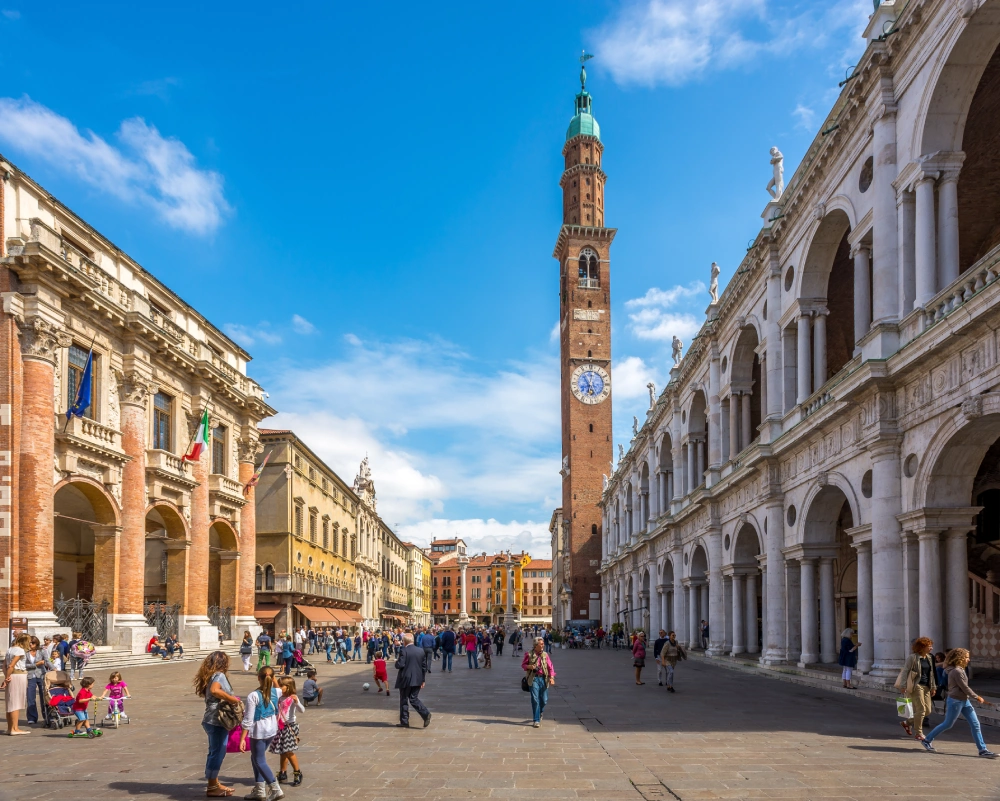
[0,97,230,234]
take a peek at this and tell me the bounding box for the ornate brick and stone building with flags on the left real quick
[0,159,273,651]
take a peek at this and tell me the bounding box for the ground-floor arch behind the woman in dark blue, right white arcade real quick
[798,485,859,663]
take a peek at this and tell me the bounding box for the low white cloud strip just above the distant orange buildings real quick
[396,518,552,559]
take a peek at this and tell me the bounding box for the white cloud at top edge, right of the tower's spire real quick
[593,0,871,86]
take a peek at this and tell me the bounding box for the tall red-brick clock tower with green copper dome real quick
[552,61,615,621]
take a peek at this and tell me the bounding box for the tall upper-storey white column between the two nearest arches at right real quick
[871,104,899,326]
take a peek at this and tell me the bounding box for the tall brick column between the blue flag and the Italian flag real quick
[113,371,157,654]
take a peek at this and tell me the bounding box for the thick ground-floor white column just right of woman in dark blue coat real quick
[868,439,908,679]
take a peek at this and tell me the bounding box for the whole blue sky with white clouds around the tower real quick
[0,0,871,555]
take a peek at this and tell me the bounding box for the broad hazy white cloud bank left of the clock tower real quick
[264,334,560,525]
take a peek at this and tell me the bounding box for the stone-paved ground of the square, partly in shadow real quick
[0,651,1000,801]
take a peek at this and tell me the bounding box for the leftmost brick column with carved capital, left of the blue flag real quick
[17,317,69,646]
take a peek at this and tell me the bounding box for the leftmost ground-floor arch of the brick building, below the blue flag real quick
[53,479,119,611]
